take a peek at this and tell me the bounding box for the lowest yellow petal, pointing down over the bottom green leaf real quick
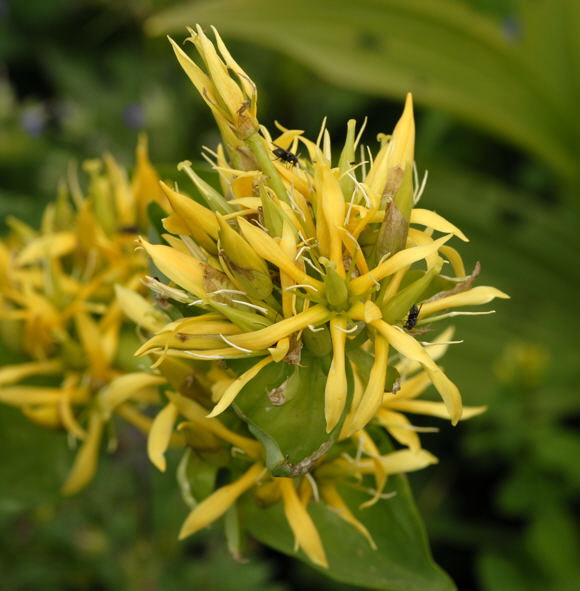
[276,478,328,568]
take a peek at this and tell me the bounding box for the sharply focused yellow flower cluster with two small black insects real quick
[120,27,508,566]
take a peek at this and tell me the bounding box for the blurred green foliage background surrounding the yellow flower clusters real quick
[0,0,580,591]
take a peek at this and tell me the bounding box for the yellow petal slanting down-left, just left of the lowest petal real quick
[179,463,265,540]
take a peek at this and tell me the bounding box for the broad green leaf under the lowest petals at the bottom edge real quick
[243,476,455,591]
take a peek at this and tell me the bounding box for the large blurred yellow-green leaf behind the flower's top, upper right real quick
[149,0,580,180]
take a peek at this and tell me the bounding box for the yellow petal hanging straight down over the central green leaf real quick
[324,318,347,433]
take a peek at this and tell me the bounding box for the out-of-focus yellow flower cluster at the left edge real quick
[0,143,168,494]
